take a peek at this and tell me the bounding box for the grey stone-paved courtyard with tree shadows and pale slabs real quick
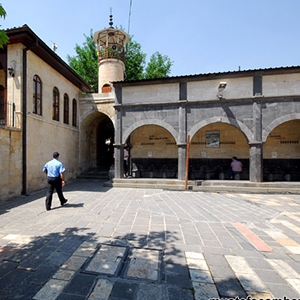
[0,180,300,300]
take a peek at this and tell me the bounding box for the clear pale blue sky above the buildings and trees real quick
[0,0,300,76]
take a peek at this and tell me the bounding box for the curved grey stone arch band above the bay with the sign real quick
[188,116,253,143]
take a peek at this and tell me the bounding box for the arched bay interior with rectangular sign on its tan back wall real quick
[189,122,249,180]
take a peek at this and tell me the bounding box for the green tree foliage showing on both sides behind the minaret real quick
[67,30,173,93]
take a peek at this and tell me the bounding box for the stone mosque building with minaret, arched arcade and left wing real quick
[0,18,300,199]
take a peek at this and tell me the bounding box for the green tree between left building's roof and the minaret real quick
[67,30,98,93]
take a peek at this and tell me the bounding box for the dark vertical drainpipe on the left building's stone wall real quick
[21,48,28,196]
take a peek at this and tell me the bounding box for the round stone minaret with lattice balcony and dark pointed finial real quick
[94,14,129,93]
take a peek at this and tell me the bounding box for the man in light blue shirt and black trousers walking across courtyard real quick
[43,152,68,210]
